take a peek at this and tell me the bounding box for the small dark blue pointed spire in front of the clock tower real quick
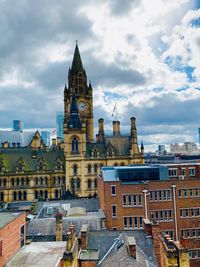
[68,92,82,129]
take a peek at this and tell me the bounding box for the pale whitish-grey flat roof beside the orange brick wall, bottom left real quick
[6,241,66,267]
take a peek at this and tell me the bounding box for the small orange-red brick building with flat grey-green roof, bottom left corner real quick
[0,212,26,267]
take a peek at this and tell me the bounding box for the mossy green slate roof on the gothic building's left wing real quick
[0,147,64,172]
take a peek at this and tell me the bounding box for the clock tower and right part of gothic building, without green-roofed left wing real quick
[64,44,144,196]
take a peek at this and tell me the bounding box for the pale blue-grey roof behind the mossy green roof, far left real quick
[0,131,36,147]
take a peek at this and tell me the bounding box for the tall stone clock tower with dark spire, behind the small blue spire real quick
[64,43,94,143]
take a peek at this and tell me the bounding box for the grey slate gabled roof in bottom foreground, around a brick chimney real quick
[87,230,157,267]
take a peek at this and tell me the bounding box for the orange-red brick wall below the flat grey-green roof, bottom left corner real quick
[0,213,26,267]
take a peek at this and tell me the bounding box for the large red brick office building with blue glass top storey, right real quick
[98,166,200,266]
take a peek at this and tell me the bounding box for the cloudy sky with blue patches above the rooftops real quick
[0,0,200,151]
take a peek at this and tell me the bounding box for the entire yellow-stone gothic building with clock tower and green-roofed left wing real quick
[0,44,144,201]
